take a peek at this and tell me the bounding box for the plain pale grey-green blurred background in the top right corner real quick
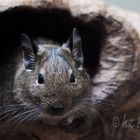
[105,0,140,12]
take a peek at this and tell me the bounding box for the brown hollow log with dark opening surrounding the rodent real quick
[0,0,140,140]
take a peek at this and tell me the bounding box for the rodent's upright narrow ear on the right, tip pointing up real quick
[72,28,84,70]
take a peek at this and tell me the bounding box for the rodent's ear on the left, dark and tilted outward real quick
[21,33,35,70]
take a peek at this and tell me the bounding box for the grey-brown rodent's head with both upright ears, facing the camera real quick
[14,29,91,124]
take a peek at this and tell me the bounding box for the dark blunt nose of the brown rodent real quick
[48,105,64,115]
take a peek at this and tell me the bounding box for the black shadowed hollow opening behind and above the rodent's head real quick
[0,7,105,77]
